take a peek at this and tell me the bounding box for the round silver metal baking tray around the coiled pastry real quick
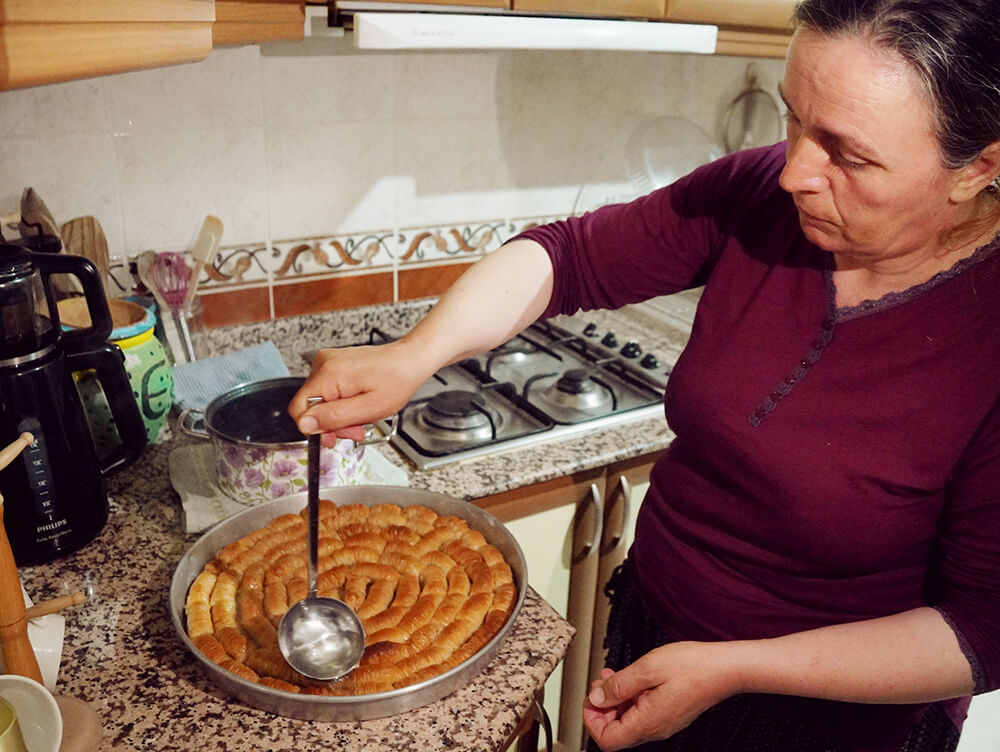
[170,486,528,721]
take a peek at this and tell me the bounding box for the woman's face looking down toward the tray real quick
[781,31,958,261]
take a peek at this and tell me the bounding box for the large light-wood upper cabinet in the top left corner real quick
[0,0,215,89]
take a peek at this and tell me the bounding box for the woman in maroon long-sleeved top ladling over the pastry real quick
[290,0,1000,751]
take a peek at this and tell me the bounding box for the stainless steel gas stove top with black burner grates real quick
[344,315,670,470]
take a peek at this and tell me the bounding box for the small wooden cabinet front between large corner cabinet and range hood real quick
[212,0,306,47]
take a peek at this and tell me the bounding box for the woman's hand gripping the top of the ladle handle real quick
[288,340,435,446]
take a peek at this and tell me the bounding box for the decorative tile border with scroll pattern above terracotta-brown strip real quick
[111,217,556,326]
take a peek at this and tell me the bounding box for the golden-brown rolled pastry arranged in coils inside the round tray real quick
[185,499,517,695]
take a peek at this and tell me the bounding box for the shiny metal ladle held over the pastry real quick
[278,412,365,681]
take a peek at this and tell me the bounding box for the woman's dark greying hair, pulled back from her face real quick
[795,0,1000,177]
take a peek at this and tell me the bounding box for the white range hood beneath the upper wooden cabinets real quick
[306,0,718,54]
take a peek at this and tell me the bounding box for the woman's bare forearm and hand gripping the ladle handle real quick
[288,239,552,444]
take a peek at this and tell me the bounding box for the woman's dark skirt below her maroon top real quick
[590,562,959,752]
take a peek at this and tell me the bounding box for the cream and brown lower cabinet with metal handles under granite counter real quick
[475,455,656,750]
